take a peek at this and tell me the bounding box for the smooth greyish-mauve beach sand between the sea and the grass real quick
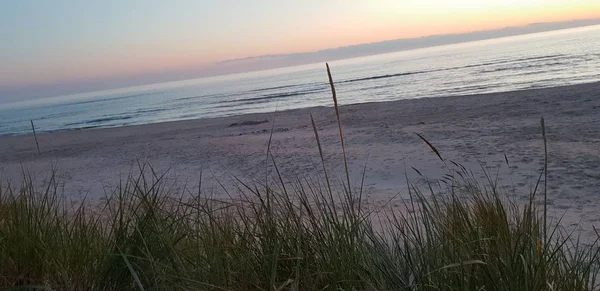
[0,83,600,236]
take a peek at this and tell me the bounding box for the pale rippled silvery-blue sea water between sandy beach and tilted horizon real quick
[0,26,600,135]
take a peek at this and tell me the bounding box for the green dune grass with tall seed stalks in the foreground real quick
[0,64,599,290]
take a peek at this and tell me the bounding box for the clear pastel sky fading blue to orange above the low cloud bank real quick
[0,0,600,102]
